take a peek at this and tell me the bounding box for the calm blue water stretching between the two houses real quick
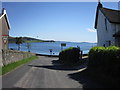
[9,41,96,55]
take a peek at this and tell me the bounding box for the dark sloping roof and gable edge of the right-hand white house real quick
[95,2,120,29]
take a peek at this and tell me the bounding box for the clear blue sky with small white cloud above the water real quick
[2,2,118,42]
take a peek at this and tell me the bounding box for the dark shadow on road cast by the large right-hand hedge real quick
[68,69,107,90]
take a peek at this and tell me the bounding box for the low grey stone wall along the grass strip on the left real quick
[2,50,35,66]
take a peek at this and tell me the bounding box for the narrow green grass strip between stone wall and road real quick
[0,56,38,75]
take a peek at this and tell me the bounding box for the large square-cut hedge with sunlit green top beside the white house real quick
[88,46,120,77]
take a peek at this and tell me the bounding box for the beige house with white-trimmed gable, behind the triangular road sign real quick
[0,8,10,66]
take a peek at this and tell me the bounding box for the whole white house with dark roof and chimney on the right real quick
[95,2,120,46]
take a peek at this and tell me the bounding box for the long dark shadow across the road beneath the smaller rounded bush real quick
[28,59,87,71]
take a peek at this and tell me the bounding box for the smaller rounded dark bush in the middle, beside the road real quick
[59,47,80,65]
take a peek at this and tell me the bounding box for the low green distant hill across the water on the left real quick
[8,36,55,43]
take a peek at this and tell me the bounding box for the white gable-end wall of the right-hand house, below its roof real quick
[97,10,116,46]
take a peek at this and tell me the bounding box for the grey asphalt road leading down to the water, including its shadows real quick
[2,56,106,89]
